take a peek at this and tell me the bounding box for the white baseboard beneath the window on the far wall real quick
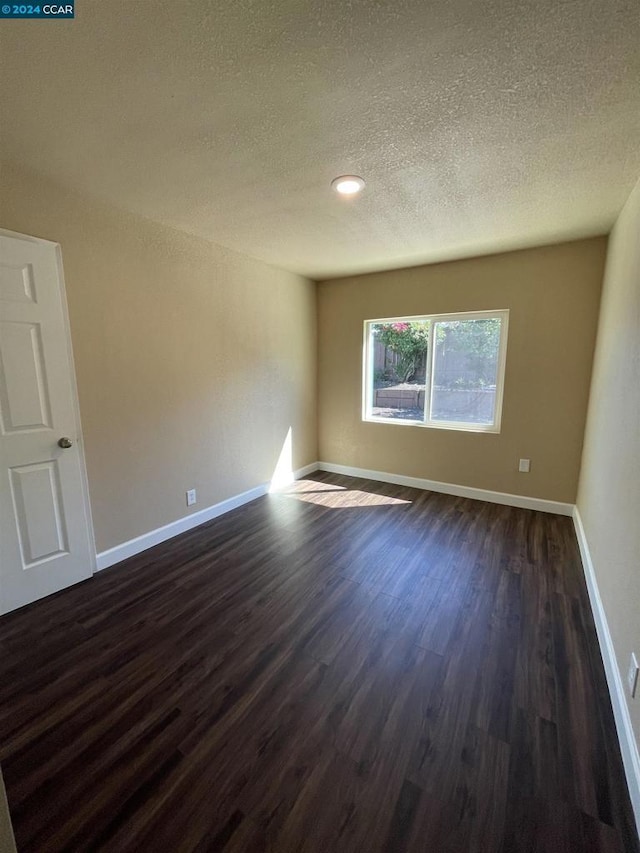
[318,462,573,516]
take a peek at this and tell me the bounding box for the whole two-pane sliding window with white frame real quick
[363,311,509,432]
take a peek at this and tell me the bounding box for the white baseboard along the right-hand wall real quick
[573,507,640,835]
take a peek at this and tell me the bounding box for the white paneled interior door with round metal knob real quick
[0,234,95,613]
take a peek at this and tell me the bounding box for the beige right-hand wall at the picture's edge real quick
[578,183,640,744]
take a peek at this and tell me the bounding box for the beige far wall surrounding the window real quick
[318,237,606,503]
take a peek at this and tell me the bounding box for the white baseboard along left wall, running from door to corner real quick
[96,462,318,572]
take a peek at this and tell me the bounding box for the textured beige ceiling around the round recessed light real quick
[0,0,640,278]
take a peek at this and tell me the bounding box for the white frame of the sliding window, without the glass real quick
[362,308,509,433]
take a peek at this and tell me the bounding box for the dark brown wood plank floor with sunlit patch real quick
[0,474,639,853]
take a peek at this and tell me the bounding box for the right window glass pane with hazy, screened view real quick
[431,317,501,424]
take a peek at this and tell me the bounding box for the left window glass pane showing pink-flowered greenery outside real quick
[369,320,429,422]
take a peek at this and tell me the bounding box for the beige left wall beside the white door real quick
[0,166,317,551]
